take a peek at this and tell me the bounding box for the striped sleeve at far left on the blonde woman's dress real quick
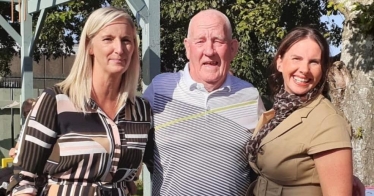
[7,89,58,195]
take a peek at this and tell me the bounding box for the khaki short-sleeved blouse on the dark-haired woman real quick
[250,95,351,196]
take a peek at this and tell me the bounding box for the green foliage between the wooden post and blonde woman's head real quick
[34,0,107,60]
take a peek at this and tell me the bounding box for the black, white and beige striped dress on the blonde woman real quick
[8,87,154,196]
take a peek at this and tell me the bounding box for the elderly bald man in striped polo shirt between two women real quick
[144,9,264,195]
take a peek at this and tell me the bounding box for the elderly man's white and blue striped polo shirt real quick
[143,65,264,196]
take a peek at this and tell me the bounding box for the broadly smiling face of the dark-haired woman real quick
[277,38,322,95]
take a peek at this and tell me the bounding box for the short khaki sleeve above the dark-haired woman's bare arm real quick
[308,114,352,155]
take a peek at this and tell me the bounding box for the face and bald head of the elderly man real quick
[184,12,238,91]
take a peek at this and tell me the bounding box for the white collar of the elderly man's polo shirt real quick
[183,63,233,92]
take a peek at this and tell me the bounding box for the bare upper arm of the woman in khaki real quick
[313,148,353,196]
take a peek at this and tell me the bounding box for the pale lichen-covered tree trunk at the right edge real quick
[331,0,374,185]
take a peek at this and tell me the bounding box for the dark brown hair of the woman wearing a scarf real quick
[269,27,331,95]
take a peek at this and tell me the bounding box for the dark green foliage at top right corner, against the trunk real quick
[353,3,374,36]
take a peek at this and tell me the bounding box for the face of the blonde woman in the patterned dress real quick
[90,19,135,76]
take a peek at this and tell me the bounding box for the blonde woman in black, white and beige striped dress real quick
[8,7,154,196]
